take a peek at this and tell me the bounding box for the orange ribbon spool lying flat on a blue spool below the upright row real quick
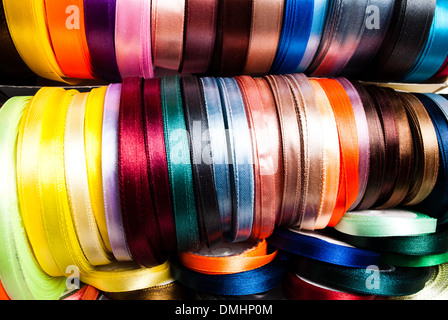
[179,240,277,275]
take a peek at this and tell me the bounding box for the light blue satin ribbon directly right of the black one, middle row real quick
[200,77,232,234]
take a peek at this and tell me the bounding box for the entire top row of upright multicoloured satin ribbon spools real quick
[0,0,448,83]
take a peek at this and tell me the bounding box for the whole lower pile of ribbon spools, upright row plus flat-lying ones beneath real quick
[0,74,448,300]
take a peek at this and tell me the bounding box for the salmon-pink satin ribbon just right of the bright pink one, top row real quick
[151,0,186,71]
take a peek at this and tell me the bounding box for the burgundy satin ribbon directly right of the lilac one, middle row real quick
[118,78,168,267]
